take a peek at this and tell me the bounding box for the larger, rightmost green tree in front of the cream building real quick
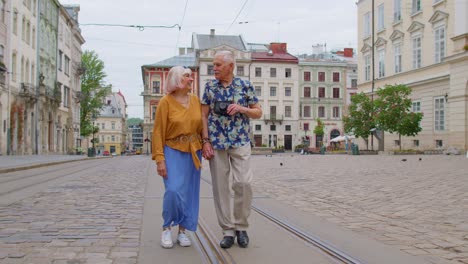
[374,84,422,150]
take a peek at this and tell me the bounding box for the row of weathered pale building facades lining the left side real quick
[0,0,84,155]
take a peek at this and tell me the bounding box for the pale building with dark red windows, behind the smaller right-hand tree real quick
[299,51,353,148]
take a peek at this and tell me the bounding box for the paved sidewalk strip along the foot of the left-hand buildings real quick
[0,154,88,173]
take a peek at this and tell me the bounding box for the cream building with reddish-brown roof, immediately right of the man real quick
[250,43,300,150]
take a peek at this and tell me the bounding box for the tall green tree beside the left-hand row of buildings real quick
[80,51,112,137]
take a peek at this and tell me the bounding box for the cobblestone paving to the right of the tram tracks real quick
[252,153,468,263]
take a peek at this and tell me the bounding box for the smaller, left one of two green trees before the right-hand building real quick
[343,92,375,148]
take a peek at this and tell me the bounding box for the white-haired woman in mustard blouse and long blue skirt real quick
[152,66,203,248]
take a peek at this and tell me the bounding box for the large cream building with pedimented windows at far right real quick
[357,0,468,150]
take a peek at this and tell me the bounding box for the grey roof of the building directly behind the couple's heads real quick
[192,30,247,50]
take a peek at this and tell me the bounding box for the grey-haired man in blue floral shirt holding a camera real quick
[201,51,262,248]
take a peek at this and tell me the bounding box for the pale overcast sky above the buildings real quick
[59,0,357,119]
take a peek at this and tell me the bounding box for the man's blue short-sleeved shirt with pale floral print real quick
[201,78,258,150]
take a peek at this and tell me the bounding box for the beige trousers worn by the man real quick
[210,144,253,236]
